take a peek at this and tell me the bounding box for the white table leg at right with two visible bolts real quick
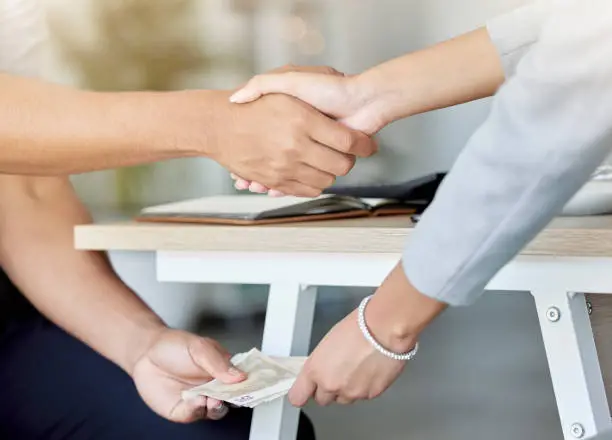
[532,289,612,440]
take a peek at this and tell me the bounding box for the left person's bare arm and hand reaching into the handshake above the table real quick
[0,73,376,196]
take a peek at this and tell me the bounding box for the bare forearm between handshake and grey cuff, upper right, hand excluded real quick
[354,28,504,124]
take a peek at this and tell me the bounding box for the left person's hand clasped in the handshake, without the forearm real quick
[212,66,378,197]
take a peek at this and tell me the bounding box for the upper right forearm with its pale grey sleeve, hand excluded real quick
[355,0,552,124]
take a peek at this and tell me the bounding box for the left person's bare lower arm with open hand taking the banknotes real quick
[0,176,260,423]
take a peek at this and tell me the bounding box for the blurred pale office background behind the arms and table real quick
[43,0,561,440]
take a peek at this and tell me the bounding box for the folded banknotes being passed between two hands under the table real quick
[183,348,306,408]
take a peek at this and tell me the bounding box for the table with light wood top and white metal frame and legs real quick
[75,216,612,440]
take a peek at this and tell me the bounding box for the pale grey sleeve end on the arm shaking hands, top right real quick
[487,0,553,78]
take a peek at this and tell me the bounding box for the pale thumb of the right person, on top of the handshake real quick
[230,72,337,104]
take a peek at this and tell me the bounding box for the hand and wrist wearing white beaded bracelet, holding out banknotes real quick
[289,263,447,407]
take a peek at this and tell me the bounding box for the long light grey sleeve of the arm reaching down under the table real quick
[402,0,612,305]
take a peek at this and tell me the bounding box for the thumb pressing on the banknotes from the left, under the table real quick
[190,338,247,384]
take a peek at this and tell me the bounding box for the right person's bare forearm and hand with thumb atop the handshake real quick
[230,28,505,134]
